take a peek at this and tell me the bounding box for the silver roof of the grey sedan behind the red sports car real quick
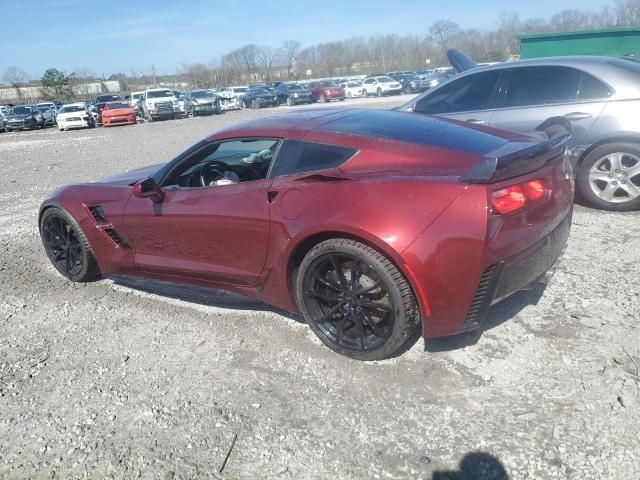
[455,55,640,99]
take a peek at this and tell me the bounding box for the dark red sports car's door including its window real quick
[124,138,280,285]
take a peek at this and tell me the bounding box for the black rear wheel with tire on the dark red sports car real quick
[295,238,421,361]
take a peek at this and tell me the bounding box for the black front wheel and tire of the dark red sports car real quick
[40,207,100,282]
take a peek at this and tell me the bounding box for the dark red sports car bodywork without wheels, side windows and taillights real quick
[40,109,573,337]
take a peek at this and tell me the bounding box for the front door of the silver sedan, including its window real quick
[413,69,503,125]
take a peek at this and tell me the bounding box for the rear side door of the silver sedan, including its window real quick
[490,66,611,149]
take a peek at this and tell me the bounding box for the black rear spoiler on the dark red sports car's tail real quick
[460,117,571,183]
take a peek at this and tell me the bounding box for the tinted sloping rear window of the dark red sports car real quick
[321,111,507,155]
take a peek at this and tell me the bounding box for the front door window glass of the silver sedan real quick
[414,70,500,115]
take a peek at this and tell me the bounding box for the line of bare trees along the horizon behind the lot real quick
[3,0,640,100]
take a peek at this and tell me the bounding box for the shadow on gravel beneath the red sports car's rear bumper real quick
[425,285,546,352]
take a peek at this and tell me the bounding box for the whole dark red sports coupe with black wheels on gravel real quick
[39,109,573,360]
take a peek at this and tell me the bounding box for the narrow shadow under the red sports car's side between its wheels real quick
[111,278,306,324]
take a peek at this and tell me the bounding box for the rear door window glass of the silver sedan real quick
[504,66,582,107]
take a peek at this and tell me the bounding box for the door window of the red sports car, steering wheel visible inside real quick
[162,138,280,189]
